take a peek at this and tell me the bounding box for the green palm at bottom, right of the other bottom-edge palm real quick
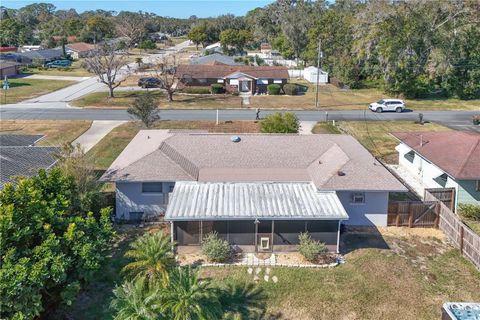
[161,267,223,320]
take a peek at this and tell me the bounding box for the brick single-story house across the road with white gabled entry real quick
[176,64,288,94]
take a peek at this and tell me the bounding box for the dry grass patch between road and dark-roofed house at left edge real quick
[0,120,92,146]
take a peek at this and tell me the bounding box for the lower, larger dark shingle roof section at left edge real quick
[0,147,60,188]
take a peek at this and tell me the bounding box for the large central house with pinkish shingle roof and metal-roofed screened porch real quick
[102,130,407,251]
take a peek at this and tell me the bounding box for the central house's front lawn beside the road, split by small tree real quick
[87,121,259,170]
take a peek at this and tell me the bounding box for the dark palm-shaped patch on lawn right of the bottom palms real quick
[219,282,266,320]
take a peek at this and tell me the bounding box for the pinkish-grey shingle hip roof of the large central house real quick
[102,130,406,191]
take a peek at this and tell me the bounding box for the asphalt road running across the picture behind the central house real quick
[0,106,480,133]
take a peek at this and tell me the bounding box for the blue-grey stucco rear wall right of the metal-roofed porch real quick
[337,191,388,227]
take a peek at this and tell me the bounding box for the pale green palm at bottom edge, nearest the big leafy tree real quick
[111,277,165,320]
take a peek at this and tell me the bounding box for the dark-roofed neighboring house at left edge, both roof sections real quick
[0,134,60,189]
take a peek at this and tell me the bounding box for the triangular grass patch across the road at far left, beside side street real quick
[0,78,75,104]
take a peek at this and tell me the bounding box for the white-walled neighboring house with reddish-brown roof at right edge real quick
[392,131,480,206]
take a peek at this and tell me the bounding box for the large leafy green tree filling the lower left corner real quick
[0,168,113,319]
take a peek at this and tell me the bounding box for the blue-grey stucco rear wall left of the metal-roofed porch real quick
[115,182,175,219]
